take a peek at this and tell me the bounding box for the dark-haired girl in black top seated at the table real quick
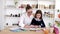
[31,10,45,27]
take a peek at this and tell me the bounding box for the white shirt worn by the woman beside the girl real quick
[19,13,33,27]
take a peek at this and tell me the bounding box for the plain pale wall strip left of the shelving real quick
[0,0,5,29]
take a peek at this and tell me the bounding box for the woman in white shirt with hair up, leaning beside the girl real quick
[19,5,33,28]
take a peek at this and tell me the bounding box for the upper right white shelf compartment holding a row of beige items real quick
[38,0,55,9]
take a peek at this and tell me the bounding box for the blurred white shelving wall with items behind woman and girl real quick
[0,0,59,30]
